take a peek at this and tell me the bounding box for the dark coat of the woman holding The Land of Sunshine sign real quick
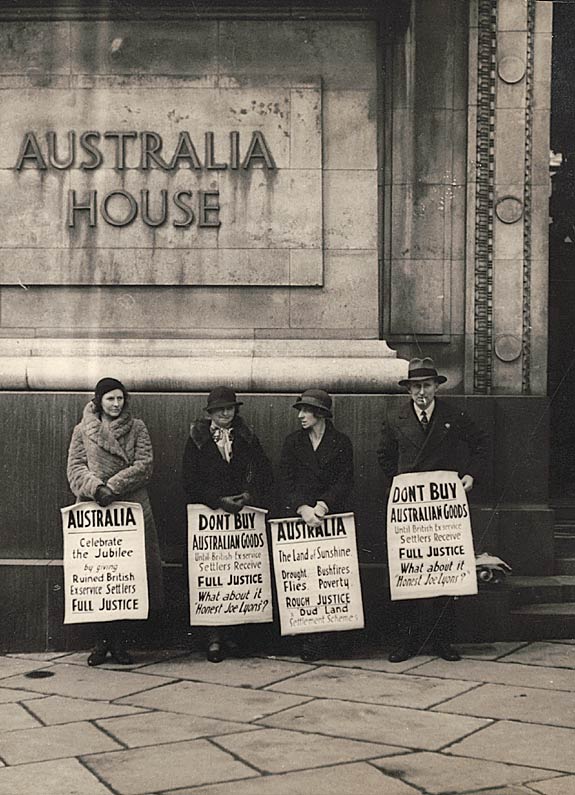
[280,420,353,516]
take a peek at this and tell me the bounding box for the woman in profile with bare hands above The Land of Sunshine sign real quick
[280,389,353,661]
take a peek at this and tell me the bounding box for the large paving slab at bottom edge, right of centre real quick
[373,752,560,795]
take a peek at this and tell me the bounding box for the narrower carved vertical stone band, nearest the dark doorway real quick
[521,0,536,395]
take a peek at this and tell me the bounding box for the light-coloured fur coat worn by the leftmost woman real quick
[67,402,163,609]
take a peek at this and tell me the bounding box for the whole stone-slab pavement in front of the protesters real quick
[0,641,575,795]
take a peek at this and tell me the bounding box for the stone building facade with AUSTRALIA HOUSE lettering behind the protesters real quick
[0,0,554,648]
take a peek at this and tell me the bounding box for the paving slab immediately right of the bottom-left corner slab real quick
[84,740,257,795]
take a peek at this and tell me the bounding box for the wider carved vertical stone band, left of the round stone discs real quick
[473,0,497,394]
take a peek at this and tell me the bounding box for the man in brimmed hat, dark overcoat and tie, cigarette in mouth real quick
[378,357,486,663]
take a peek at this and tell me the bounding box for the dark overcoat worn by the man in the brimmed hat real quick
[377,398,487,480]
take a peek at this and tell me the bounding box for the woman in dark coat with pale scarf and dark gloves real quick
[182,386,273,662]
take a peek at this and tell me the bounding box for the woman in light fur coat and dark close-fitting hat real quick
[67,378,163,665]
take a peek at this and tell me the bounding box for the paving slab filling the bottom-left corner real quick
[0,759,110,795]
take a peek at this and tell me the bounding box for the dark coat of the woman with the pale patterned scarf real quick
[182,415,273,509]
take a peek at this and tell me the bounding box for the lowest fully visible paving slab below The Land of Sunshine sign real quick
[217,729,397,773]
